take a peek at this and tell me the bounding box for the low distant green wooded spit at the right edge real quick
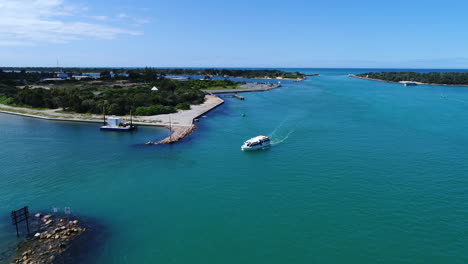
[355,72,468,85]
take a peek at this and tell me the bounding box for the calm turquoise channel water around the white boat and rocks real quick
[0,70,468,264]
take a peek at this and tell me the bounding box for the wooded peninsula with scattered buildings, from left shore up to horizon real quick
[0,69,241,116]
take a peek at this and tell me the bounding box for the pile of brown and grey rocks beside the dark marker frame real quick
[13,213,87,264]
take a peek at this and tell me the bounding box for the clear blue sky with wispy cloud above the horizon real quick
[0,0,468,69]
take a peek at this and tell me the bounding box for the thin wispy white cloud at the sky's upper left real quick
[0,0,142,46]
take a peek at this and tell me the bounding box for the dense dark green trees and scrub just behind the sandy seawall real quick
[0,75,236,115]
